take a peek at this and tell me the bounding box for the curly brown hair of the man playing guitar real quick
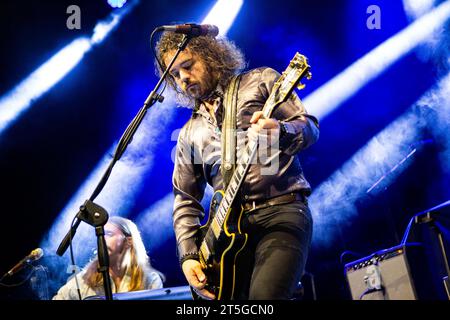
[155,32,246,105]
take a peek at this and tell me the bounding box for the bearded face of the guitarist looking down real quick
[164,49,217,100]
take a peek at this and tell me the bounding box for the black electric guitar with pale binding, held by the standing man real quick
[191,52,311,300]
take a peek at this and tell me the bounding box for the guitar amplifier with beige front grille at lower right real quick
[345,244,435,300]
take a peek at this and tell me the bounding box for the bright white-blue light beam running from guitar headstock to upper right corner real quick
[303,0,450,119]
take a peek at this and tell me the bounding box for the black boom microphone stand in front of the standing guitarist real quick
[56,35,191,300]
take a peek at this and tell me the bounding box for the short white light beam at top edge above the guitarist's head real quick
[202,0,244,36]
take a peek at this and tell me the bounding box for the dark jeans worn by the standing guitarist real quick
[235,201,312,300]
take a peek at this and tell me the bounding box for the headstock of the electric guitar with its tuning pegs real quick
[274,52,312,104]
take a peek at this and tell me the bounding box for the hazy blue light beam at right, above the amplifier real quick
[309,73,450,247]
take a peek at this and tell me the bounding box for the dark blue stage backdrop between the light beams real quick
[0,0,450,300]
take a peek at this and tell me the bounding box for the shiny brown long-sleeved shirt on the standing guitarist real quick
[173,68,319,259]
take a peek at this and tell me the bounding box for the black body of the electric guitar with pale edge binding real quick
[191,190,247,300]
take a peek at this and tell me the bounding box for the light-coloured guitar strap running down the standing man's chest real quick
[220,75,240,190]
